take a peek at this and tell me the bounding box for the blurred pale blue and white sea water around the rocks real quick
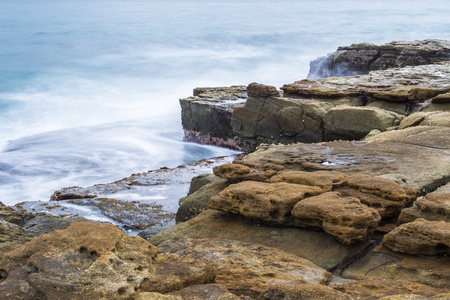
[0,0,450,205]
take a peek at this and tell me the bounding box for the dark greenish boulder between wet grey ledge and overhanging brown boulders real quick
[175,177,229,223]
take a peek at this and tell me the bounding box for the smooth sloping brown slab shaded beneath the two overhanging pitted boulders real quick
[149,209,370,270]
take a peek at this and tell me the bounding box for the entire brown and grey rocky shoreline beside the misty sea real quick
[0,40,450,300]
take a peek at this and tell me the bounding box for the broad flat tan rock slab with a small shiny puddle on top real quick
[236,126,450,194]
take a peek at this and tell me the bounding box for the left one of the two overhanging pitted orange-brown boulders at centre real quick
[209,181,322,224]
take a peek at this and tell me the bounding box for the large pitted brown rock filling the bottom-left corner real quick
[0,223,156,299]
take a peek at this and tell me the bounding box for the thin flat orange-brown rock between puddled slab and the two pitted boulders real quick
[268,171,344,192]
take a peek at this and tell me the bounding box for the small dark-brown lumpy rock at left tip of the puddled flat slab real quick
[213,164,277,183]
